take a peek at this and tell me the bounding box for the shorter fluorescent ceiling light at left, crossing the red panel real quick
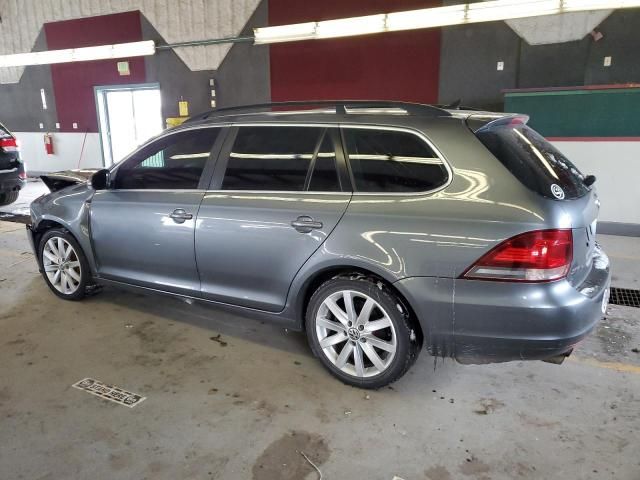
[0,40,156,67]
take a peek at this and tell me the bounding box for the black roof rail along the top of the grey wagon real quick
[185,100,451,123]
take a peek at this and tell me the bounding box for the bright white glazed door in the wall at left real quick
[96,86,162,167]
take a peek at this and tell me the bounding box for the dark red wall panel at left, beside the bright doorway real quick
[44,11,146,132]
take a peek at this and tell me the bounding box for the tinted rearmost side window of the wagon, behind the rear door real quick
[345,129,447,192]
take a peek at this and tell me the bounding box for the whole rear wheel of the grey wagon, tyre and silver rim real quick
[306,277,420,389]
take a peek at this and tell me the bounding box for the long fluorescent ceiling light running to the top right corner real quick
[254,0,640,43]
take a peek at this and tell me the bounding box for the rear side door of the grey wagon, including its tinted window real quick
[195,125,351,312]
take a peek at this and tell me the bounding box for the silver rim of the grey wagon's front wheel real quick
[42,237,82,295]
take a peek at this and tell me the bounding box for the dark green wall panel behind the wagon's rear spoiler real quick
[505,88,640,137]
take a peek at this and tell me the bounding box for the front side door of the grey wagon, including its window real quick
[90,127,223,295]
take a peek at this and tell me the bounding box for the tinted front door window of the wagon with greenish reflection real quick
[115,128,220,190]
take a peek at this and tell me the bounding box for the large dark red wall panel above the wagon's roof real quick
[269,0,441,103]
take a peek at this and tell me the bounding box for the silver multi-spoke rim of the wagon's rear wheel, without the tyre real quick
[316,290,397,378]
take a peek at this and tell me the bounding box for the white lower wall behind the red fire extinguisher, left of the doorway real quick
[13,132,102,173]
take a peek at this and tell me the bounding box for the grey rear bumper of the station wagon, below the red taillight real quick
[397,250,611,363]
